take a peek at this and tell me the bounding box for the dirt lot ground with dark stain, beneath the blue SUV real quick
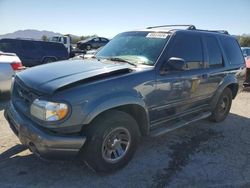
[0,92,250,188]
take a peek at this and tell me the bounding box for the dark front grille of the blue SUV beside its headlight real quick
[11,77,38,115]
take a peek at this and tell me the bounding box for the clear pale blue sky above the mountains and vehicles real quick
[0,0,250,38]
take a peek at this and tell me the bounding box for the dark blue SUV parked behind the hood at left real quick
[0,39,69,67]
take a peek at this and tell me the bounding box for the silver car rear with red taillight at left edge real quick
[0,51,24,101]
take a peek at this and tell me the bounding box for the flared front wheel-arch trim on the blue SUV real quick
[82,95,149,129]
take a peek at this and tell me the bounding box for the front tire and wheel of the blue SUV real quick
[80,110,140,172]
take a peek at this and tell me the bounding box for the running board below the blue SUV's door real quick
[149,112,211,137]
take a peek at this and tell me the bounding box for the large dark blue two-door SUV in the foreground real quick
[4,25,245,172]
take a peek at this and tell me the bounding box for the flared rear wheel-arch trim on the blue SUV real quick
[210,74,239,111]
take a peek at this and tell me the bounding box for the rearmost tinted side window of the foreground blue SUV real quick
[221,37,244,64]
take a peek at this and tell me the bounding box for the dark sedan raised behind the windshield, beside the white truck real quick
[77,37,109,50]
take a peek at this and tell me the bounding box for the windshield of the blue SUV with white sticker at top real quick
[96,31,169,65]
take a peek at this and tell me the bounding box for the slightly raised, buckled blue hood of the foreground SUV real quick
[17,60,133,94]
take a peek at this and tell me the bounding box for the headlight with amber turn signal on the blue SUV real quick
[30,99,69,121]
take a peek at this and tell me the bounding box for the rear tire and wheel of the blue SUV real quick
[209,88,232,122]
